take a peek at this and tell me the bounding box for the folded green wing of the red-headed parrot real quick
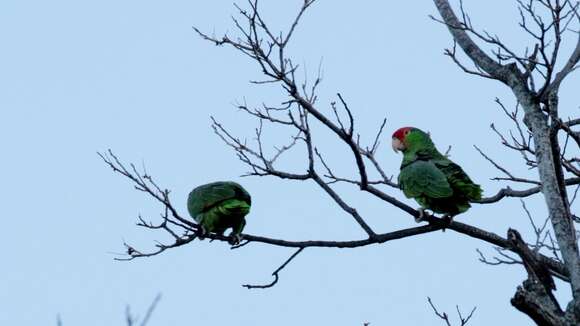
[399,160,453,198]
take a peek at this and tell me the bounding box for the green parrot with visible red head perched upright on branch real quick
[392,127,482,222]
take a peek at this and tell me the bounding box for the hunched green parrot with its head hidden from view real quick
[187,181,252,245]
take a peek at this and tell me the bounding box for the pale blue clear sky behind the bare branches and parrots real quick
[0,0,580,326]
